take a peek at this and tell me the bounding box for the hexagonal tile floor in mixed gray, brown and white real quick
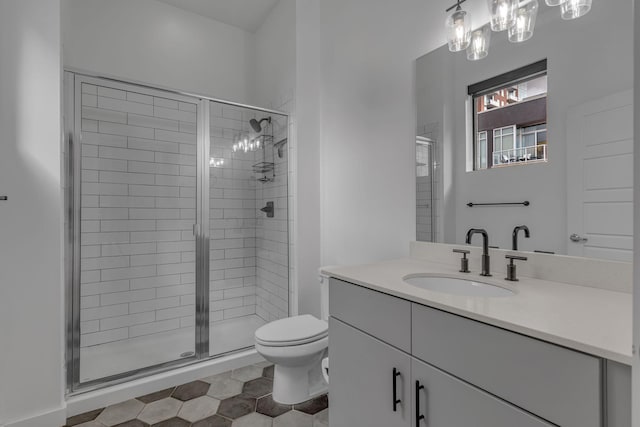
[64,363,329,427]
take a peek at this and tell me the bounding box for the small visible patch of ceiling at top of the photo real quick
[158,0,278,33]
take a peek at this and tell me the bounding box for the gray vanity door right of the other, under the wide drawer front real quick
[411,359,553,427]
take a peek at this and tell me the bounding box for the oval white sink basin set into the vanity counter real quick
[404,276,514,297]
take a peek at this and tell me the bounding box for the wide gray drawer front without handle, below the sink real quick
[412,304,602,427]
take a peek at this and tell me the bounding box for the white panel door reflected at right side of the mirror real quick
[567,91,633,261]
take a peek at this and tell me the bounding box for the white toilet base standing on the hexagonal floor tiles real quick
[272,354,328,405]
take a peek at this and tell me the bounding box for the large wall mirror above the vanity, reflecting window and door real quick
[416,0,633,261]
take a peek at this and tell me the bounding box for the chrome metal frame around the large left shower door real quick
[64,71,210,395]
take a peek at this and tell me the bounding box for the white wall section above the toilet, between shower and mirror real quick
[319,0,444,264]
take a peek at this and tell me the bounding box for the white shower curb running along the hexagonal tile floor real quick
[66,349,264,418]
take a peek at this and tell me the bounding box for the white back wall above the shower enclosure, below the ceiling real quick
[62,0,255,103]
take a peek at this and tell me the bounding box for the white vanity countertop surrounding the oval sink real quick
[322,258,632,365]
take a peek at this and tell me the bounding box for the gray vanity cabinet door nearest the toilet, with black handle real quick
[329,317,411,427]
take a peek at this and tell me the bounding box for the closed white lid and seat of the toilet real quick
[256,314,329,347]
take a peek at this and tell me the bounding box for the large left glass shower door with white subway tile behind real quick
[73,76,202,384]
